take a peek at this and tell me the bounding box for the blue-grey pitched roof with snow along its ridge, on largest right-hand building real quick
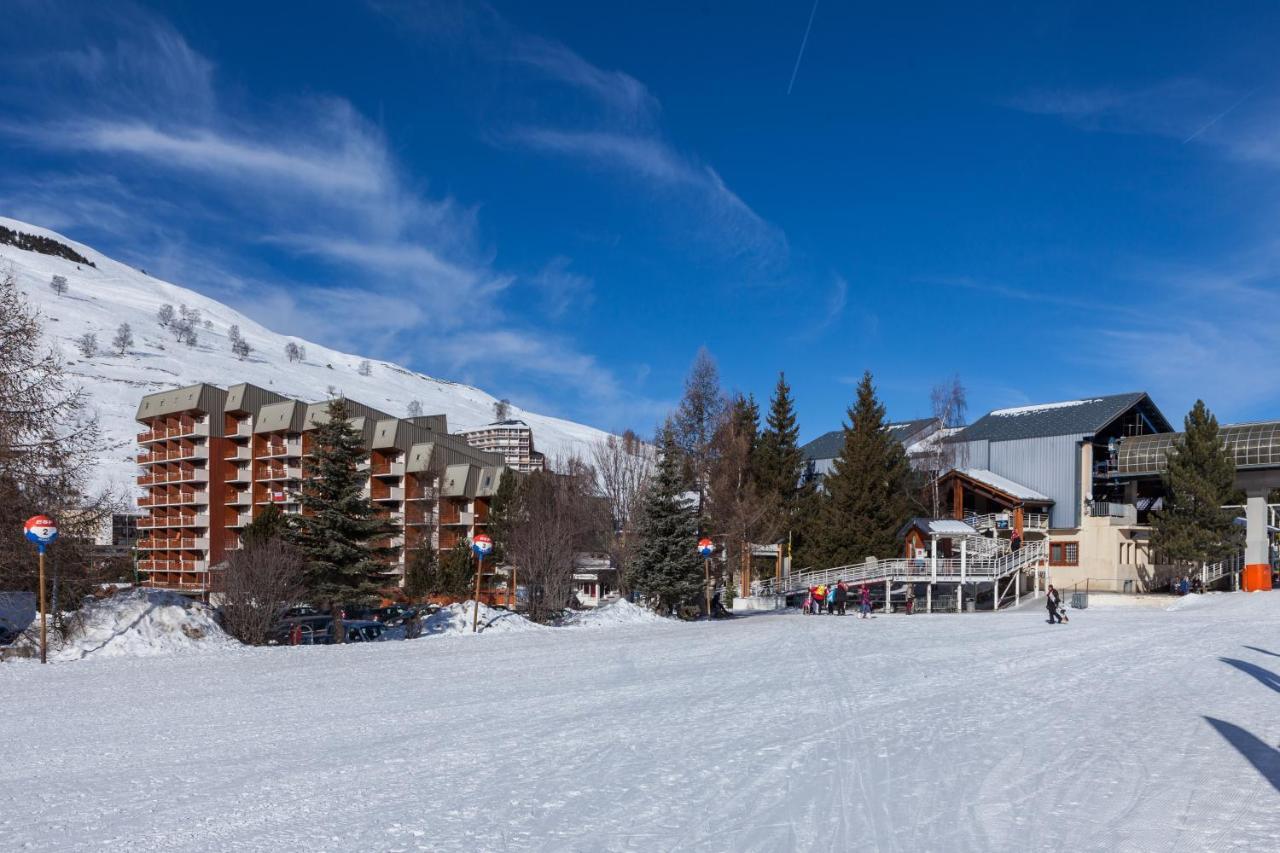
[951,391,1171,442]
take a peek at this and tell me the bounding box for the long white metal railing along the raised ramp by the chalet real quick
[751,542,1048,596]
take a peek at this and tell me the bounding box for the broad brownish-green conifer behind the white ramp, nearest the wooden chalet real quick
[803,371,913,566]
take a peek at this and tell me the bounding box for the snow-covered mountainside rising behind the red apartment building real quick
[0,216,605,496]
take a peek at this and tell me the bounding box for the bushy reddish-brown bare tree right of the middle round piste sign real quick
[506,459,608,621]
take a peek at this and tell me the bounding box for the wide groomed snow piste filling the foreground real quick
[0,593,1280,852]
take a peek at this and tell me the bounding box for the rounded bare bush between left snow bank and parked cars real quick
[214,537,306,646]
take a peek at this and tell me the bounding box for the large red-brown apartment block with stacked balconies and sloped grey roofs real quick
[137,384,504,597]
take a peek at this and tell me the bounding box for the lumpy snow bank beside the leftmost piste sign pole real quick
[50,589,241,661]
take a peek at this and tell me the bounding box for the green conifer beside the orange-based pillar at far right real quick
[1151,400,1243,564]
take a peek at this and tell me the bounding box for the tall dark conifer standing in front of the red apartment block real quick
[292,398,397,638]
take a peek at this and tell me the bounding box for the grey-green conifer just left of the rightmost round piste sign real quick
[627,424,703,613]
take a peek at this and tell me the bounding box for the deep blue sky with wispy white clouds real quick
[0,0,1280,438]
